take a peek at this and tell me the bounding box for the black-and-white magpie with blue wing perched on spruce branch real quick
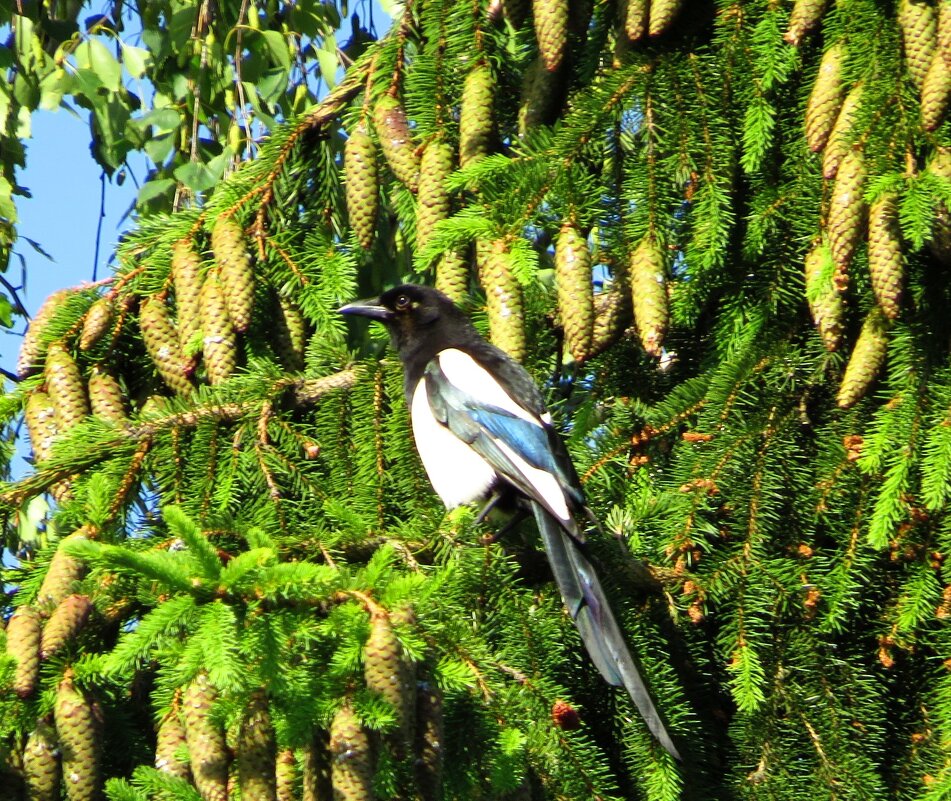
[338,284,680,760]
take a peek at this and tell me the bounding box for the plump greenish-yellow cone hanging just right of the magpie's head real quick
[477,239,525,361]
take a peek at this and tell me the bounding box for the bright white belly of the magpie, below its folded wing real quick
[410,376,494,509]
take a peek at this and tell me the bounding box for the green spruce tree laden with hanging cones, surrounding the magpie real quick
[0,0,951,801]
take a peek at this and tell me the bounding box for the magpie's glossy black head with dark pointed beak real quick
[338,284,477,361]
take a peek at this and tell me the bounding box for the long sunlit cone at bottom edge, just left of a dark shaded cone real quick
[182,672,228,801]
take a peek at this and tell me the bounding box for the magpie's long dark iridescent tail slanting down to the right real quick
[532,502,680,760]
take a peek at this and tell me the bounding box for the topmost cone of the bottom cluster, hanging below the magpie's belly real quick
[363,613,416,745]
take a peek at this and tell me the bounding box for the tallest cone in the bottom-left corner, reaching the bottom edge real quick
[54,672,102,801]
